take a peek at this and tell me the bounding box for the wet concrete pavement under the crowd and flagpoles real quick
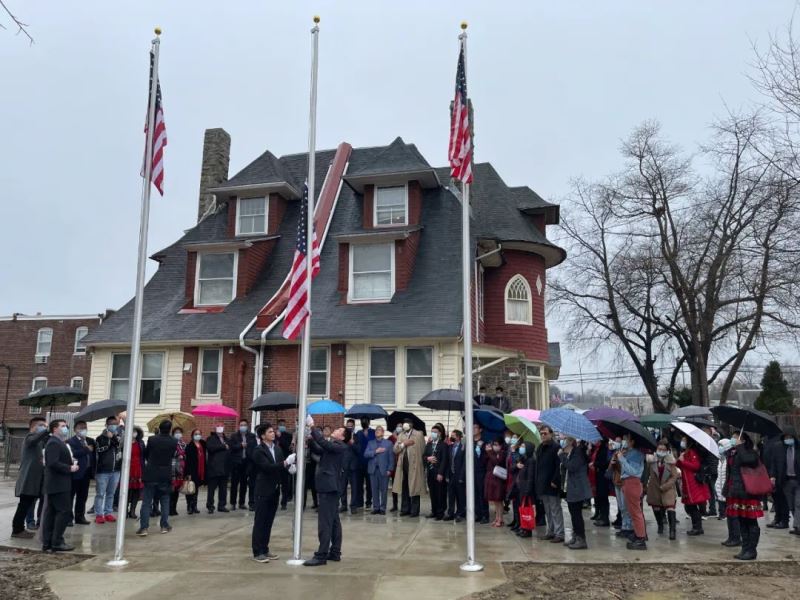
[0,482,800,600]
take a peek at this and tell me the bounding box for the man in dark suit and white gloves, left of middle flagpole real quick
[251,423,297,563]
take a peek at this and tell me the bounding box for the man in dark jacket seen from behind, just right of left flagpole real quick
[136,420,178,537]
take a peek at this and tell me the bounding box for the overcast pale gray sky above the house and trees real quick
[0,0,795,392]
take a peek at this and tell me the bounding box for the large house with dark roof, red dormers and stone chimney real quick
[86,129,565,434]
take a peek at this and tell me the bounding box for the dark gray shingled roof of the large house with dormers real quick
[85,138,563,344]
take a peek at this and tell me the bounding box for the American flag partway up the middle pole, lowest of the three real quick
[283,183,319,340]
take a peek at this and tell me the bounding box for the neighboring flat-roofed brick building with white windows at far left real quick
[0,313,106,432]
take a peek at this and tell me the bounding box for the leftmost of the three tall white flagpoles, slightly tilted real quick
[107,27,161,567]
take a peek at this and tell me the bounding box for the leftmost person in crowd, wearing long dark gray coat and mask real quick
[11,417,50,539]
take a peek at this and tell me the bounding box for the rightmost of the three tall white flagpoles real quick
[458,23,483,571]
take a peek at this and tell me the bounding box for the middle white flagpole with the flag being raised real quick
[286,16,319,566]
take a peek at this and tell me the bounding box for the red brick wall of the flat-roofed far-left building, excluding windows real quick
[0,318,100,428]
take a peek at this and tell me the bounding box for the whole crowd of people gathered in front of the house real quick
[7,410,800,566]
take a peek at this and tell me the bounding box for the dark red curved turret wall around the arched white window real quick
[484,250,548,361]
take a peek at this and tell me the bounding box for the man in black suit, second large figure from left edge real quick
[42,419,78,552]
